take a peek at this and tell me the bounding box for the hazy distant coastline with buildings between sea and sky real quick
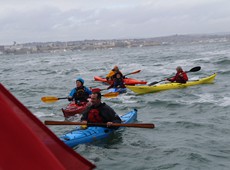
[0,33,230,55]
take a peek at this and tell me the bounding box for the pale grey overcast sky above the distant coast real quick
[0,0,230,45]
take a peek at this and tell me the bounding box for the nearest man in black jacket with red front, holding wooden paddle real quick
[81,92,121,129]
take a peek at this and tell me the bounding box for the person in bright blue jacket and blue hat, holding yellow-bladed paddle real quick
[68,78,92,104]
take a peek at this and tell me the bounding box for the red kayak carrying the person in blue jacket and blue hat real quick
[62,101,88,118]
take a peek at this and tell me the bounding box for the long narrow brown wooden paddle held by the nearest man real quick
[44,120,155,128]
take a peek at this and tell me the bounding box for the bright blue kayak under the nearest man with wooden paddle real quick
[60,109,137,148]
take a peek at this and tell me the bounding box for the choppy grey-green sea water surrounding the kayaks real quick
[0,40,230,170]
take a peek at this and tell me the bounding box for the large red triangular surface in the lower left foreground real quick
[0,84,95,170]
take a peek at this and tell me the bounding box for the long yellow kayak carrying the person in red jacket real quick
[126,73,217,94]
